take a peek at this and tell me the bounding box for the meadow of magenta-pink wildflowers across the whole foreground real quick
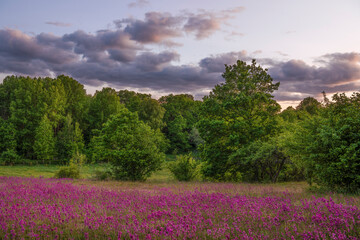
[0,177,360,239]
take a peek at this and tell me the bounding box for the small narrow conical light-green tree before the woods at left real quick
[34,115,55,163]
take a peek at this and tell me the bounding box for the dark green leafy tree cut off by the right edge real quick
[296,93,360,192]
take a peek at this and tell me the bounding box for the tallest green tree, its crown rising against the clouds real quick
[197,60,280,180]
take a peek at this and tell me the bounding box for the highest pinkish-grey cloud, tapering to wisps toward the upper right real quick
[114,6,244,46]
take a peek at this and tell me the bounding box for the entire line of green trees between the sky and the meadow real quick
[0,60,360,192]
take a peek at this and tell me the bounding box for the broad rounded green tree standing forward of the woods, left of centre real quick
[92,108,165,181]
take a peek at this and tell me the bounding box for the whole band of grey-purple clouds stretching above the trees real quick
[0,8,360,101]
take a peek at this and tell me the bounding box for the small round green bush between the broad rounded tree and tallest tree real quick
[168,154,199,181]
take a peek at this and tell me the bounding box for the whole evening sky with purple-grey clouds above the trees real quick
[0,0,360,108]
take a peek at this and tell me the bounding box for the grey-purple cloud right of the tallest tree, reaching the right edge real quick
[269,52,360,99]
